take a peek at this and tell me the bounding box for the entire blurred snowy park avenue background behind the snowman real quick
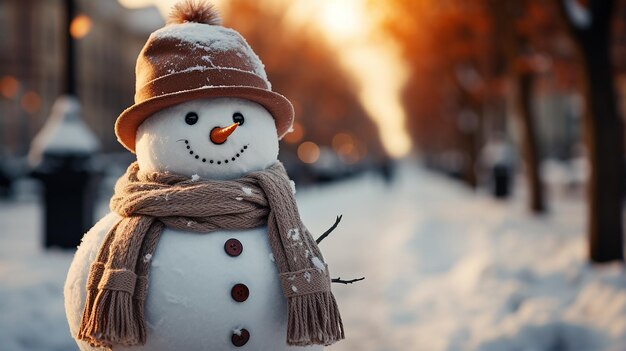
[0,0,626,351]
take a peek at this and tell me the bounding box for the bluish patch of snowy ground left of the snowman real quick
[0,201,76,351]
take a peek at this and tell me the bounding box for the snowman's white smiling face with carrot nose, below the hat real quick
[135,98,278,179]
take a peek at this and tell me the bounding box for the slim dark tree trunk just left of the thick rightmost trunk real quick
[515,72,546,213]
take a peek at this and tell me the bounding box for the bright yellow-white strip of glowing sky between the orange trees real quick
[318,0,411,157]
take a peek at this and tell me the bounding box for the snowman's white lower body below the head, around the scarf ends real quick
[65,213,322,351]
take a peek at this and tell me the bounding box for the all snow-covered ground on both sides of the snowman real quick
[0,164,626,351]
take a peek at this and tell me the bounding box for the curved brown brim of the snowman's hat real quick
[115,86,294,153]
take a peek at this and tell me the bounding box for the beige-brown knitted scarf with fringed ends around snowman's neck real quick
[78,162,344,348]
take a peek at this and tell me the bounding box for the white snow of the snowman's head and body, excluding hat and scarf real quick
[65,98,323,351]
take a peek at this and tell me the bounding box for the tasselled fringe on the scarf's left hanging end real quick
[78,289,146,348]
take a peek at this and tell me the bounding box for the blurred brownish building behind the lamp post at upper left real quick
[0,0,163,155]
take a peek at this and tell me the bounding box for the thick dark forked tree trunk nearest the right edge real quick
[559,0,625,262]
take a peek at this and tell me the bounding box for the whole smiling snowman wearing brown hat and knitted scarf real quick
[64,1,344,351]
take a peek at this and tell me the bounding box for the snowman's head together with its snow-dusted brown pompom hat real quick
[115,0,294,179]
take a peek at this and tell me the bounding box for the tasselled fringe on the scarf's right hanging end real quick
[287,291,345,346]
